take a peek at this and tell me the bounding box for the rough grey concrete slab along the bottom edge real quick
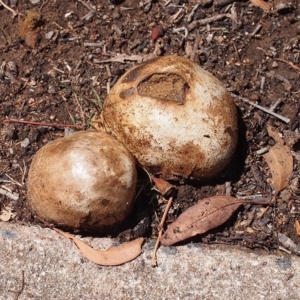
[0,222,300,300]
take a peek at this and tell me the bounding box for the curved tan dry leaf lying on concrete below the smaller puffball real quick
[53,228,144,266]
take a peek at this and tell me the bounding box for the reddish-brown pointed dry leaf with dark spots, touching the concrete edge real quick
[161,196,245,246]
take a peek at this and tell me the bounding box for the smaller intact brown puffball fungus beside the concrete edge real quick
[28,131,137,231]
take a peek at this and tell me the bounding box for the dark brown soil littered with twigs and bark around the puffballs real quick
[0,0,300,253]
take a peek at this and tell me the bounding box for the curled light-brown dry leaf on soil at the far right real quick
[263,127,293,192]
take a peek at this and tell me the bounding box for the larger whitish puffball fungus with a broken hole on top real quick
[103,56,238,179]
